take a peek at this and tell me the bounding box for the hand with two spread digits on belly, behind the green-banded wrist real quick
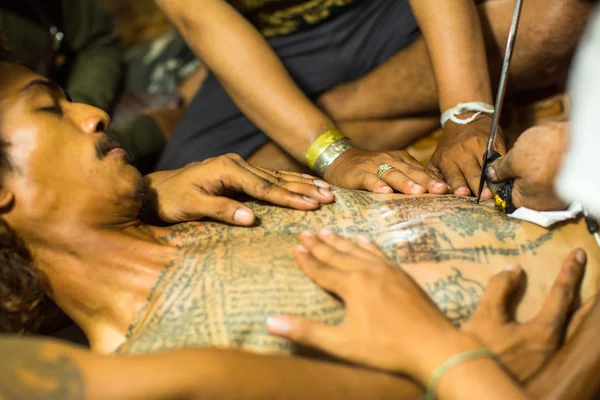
[462,250,586,382]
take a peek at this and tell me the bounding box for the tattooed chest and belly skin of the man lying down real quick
[118,189,597,353]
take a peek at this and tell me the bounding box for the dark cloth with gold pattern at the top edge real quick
[229,0,364,37]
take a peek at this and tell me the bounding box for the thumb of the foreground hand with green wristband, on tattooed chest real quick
[267,316,346,356]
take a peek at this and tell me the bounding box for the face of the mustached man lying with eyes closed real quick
[0,63,141,236]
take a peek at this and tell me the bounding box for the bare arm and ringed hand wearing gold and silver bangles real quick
[157,0,449,194]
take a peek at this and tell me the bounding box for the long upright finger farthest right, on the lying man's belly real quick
[535,249,587,328]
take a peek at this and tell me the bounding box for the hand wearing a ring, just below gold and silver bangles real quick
[325,148,449,194]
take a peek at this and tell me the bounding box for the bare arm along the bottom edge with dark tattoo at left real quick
[0,337,419,400]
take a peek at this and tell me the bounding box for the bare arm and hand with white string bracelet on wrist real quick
[410,0,510,198]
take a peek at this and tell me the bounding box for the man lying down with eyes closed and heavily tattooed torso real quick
[0,65,600,360]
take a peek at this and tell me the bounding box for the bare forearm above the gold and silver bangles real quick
[156,0,334,163]
